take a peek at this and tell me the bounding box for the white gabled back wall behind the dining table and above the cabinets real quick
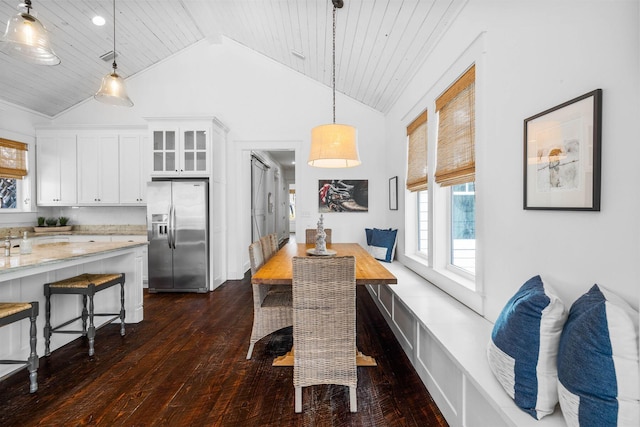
[52,39,389,279]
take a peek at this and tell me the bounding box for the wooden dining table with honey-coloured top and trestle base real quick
[251,242,398,366]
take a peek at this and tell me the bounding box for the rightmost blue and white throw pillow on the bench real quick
[558,285,640,427]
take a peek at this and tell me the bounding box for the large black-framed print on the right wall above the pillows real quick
[523,89,602,211]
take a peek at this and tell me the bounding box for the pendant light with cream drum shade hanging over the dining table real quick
[308,0,360,168]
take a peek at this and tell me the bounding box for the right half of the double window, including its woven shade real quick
[435,66,476,275]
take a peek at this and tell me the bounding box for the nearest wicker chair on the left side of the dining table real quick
[247,241,293,359]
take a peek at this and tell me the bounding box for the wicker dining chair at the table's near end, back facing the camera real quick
[293,256,358,412]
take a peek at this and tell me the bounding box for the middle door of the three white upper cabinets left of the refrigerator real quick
[77,135,120,205]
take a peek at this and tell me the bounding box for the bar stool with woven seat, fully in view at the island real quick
[44,273,125,356]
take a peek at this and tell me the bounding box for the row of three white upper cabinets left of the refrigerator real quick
[36,126,151,206]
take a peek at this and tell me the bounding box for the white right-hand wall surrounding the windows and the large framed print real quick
[386,0,640,321]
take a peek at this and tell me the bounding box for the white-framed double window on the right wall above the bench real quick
[399,42,486,314]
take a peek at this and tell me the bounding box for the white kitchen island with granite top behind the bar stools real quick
[0,242,147,377]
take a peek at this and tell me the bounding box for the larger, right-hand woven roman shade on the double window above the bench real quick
[435,65,476,187]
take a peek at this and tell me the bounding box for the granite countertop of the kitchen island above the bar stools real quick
[0,242,147,275]
